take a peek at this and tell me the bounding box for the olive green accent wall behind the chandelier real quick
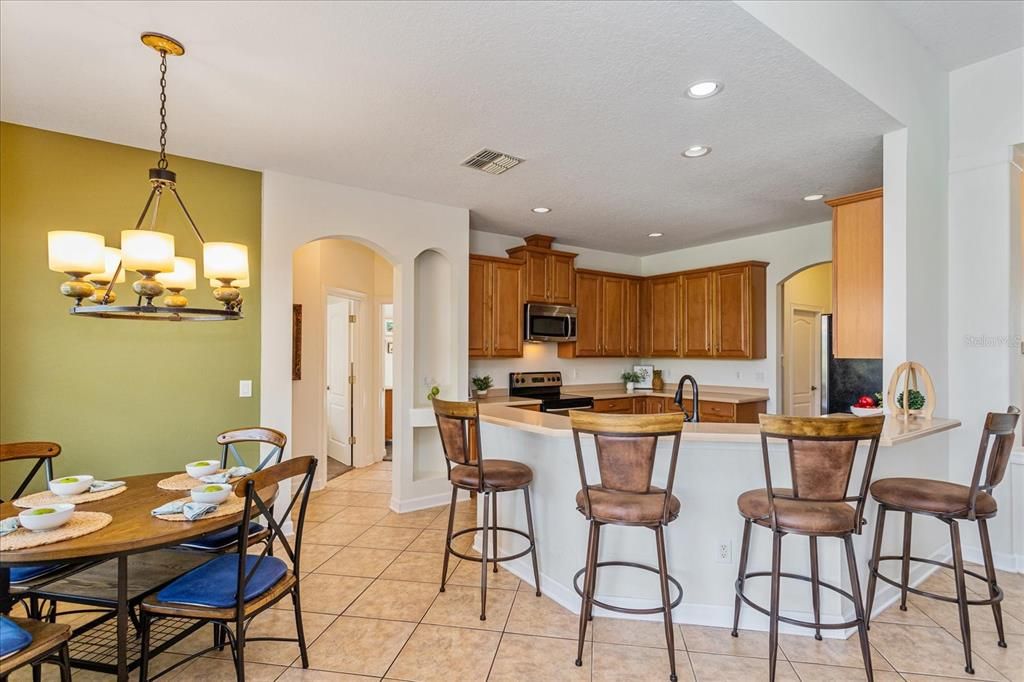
[0,123,261,485]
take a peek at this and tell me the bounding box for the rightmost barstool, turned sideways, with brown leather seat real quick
[866,407,1021,675]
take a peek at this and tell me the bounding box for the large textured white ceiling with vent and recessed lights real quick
[0,2,899,255]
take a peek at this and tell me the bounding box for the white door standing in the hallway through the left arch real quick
[326,296,355,465]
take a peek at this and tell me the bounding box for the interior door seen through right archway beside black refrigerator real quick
[783,308,821,417]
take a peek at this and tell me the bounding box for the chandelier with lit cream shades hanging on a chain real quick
[47,33,249,322]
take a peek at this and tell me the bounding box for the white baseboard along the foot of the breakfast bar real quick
[473,540,952,639]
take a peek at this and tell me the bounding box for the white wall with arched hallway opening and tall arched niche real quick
[260,171,469,510]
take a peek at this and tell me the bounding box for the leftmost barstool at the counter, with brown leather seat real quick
[433,398,541,621]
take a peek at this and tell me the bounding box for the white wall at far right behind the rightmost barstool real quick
[948,49,1024,570]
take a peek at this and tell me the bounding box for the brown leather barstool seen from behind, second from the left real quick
[569,411,684,682]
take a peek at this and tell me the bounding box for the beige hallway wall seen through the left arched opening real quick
[290,240,394,482]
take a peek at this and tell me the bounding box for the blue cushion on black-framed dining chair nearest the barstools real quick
[157,554,288,608]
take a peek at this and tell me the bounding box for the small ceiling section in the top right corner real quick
[882,0,1024,71]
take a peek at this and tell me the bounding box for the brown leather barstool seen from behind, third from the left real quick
[732,415,885,680]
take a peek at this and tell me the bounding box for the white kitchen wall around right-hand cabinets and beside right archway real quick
[642,222,831,412]
